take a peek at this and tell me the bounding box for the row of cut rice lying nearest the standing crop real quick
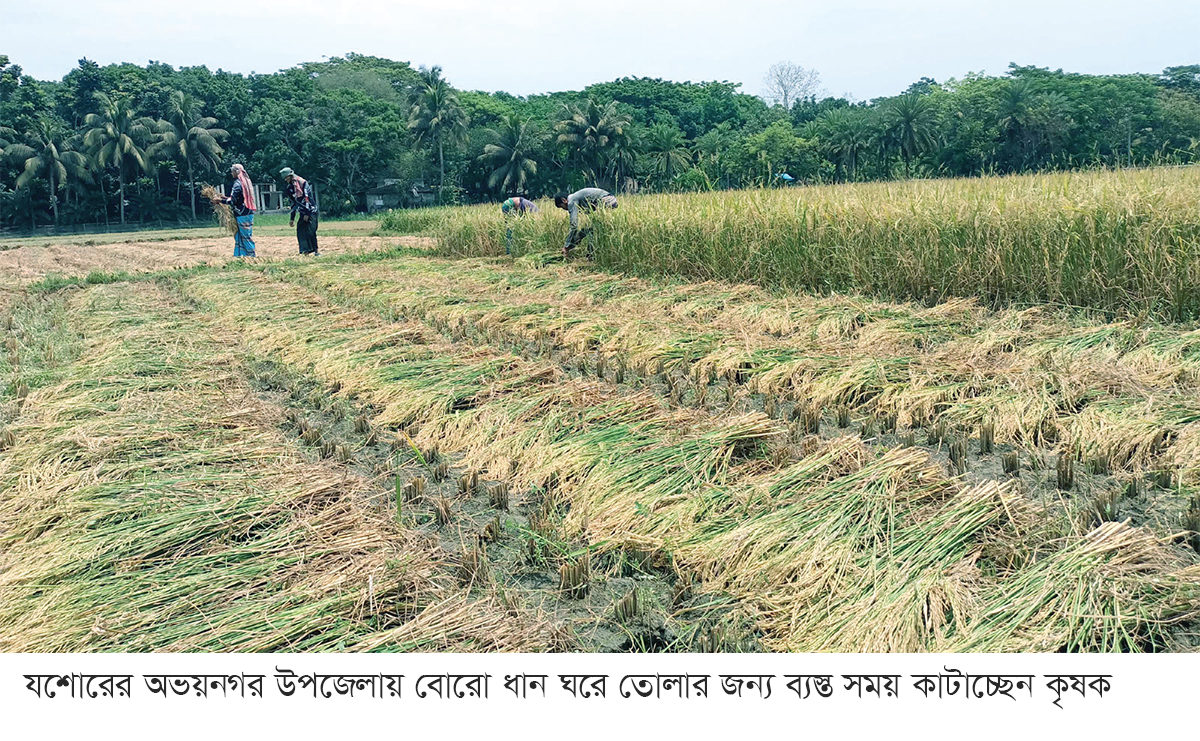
[255,259,1200,482]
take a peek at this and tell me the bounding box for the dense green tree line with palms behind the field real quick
[0,54,1200,228]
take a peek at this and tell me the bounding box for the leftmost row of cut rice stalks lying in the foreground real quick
[0,279,546,651]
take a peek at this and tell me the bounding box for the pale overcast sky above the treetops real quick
[0,0,1200,100]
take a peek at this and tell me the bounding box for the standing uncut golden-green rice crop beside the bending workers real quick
[380,167,1200,320]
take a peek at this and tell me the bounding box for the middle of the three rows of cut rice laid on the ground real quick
[188,269,1200,651]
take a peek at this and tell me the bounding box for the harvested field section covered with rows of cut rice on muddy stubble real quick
[0,176,1200,652]
